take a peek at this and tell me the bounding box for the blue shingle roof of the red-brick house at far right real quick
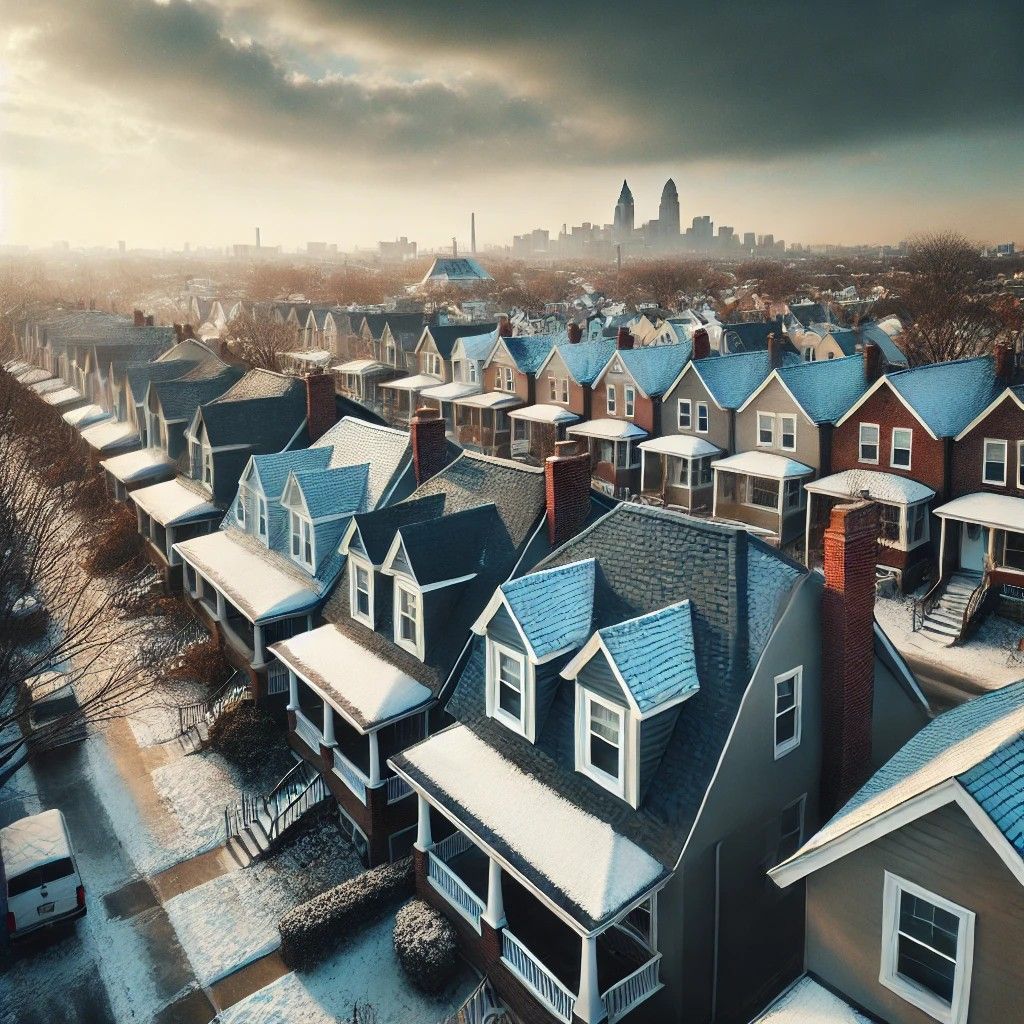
[888,355,999,437]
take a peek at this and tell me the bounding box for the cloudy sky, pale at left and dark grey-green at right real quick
[0,0,1024,249]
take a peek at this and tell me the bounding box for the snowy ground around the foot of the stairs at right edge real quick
[874,594,1024,690]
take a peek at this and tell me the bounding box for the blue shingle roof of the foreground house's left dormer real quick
[502,558,596,657]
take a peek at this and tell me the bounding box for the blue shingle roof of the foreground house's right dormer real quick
[598,600,700,714]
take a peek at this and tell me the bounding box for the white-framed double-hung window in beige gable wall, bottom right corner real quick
[880,871,975,1024]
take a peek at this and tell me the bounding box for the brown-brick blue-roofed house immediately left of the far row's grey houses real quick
[566,328,692,498]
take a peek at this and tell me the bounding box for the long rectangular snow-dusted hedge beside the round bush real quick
[278,857,414,971]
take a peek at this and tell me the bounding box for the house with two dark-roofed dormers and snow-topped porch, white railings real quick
[273,423,591,864]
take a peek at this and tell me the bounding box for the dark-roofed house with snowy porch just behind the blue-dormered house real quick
[129,370,315,590]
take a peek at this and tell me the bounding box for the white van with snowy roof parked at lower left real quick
[0,810,86,939]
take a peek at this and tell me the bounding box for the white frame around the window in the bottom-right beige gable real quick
[879,871,975,1024]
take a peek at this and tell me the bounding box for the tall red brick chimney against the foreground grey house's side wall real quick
[821,502,879,816]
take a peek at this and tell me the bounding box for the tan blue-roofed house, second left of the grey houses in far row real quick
[509,324,615,465]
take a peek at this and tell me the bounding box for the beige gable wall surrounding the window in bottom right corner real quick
[807,806,1024,1024]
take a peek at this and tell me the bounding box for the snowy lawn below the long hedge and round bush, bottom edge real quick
[217,914,476,1024]
